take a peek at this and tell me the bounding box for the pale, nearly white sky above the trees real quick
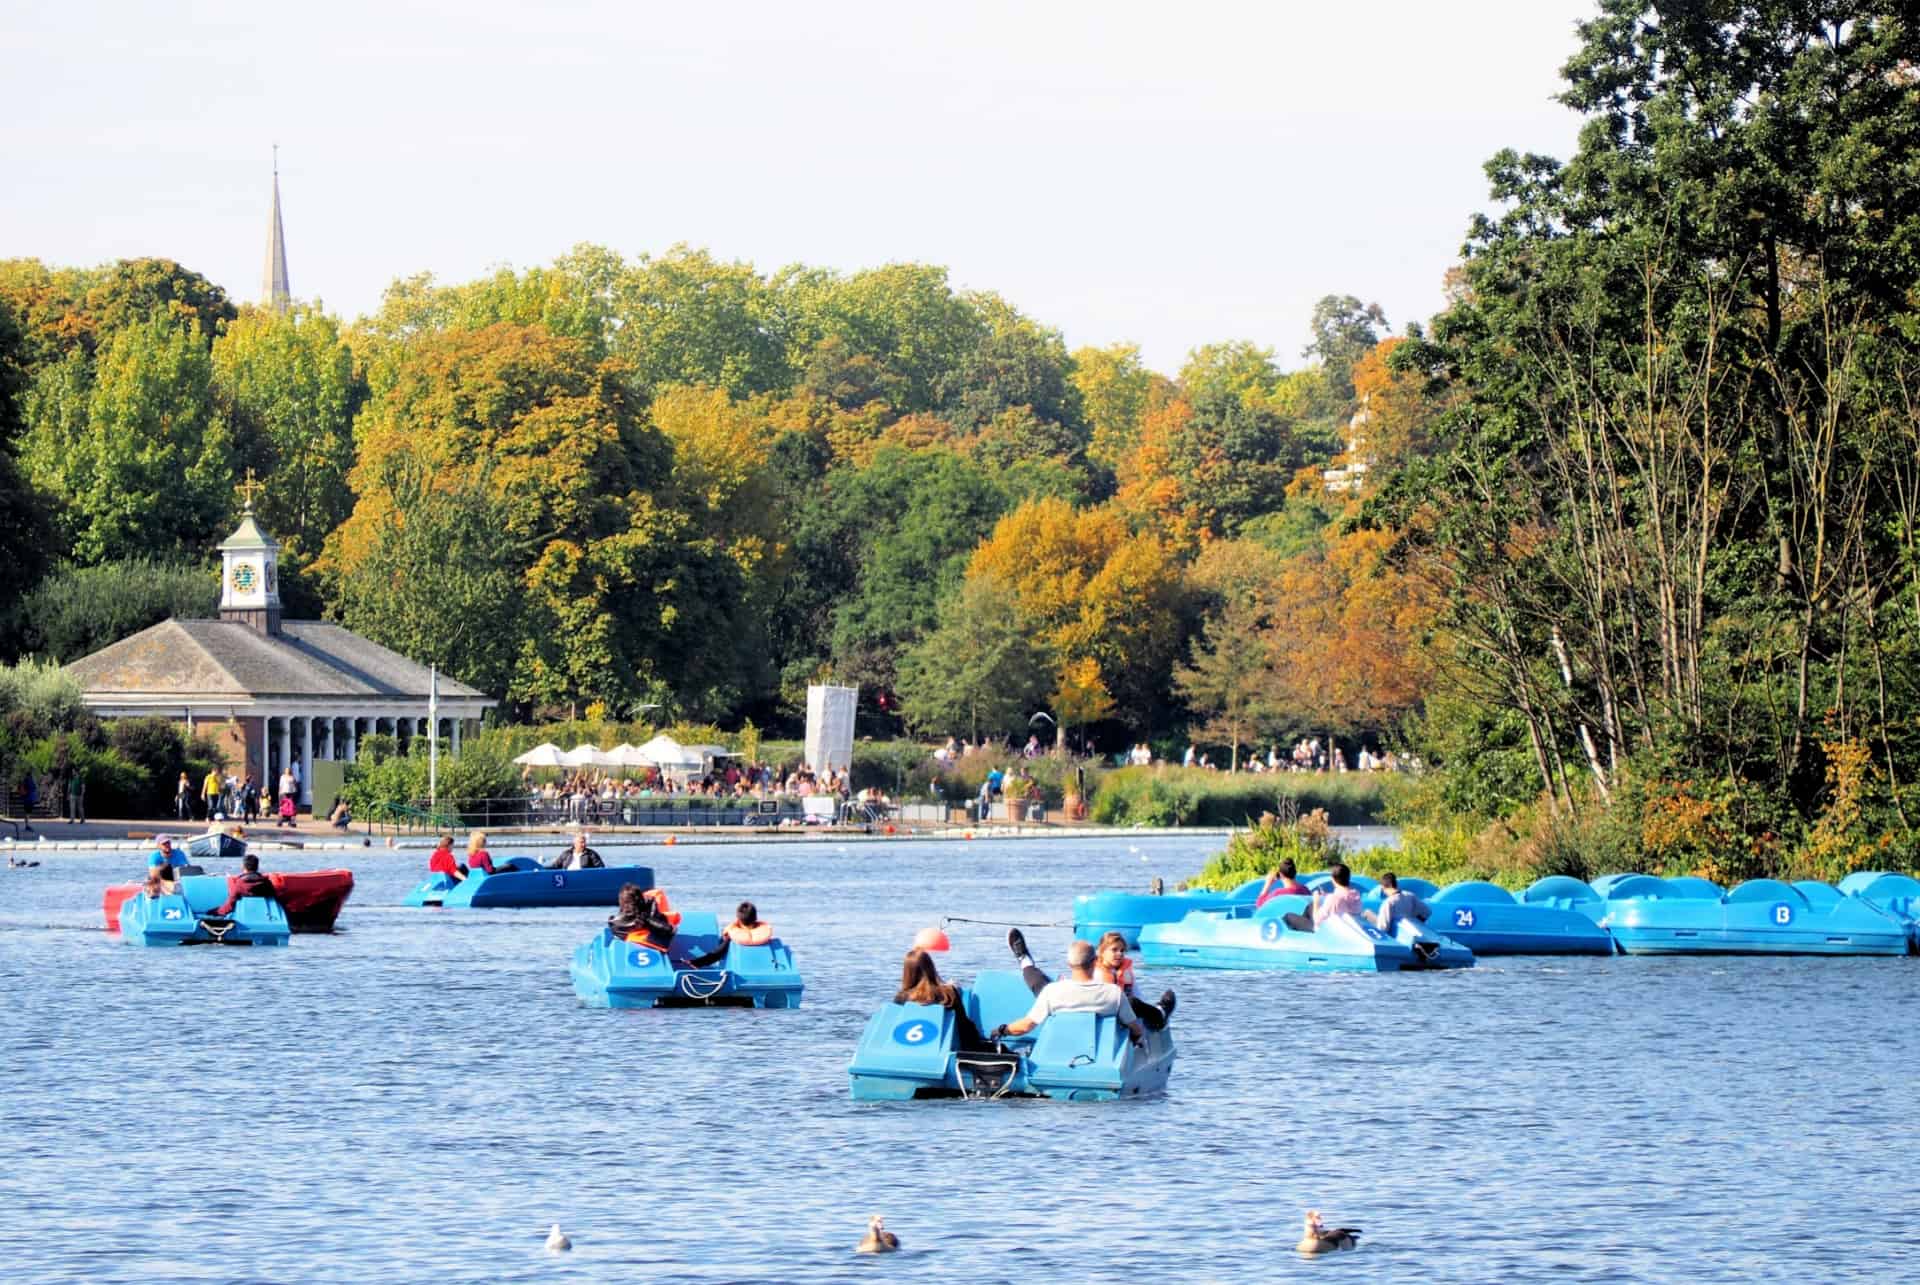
[0,0,1592,371]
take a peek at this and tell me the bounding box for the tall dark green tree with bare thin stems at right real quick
[1375,0,1920,822]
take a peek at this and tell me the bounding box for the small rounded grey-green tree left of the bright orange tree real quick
[899,576,1052,741]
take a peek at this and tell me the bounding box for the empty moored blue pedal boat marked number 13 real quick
[1596,874,1908,955]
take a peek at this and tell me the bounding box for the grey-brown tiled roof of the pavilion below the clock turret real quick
[67,620,486,701]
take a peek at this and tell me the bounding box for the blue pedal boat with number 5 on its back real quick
[570,910,804,1008]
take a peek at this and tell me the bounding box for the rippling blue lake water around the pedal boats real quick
[0,825,1920,1283]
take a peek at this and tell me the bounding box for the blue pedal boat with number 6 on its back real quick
[847,970,1175,1103]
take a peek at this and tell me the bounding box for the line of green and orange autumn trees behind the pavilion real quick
[0,246,1428,756]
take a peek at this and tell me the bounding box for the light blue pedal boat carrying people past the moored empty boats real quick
[1140,897,1473,972]
